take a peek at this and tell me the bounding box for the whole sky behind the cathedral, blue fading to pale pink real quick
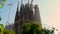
[0,0,60,31]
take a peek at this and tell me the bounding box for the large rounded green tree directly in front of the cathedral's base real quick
[22,23,42,34]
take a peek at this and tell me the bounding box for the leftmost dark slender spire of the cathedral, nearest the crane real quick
[13,2,21,34]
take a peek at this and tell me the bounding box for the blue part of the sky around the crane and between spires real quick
[0,0,40,25]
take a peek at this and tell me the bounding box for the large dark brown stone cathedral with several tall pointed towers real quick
[13,0,41,34]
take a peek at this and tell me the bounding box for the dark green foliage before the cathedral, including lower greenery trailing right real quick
[22,23,54,34]
